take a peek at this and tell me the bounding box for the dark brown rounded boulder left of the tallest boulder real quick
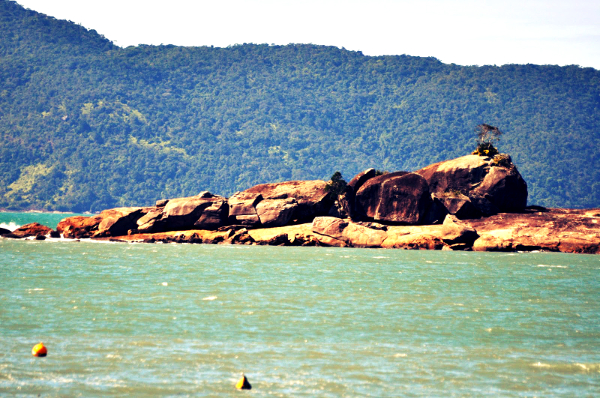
[355,171,432,224]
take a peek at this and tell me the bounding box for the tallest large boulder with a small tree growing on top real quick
[415,155,527,216]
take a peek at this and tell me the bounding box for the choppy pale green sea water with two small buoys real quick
[0,213,600,397]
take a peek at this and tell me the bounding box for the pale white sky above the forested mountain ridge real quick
[16,0,600,69]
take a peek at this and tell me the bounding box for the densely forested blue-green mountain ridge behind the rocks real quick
[0,0,600,212]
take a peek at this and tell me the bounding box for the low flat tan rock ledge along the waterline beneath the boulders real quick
[65,208,600,254]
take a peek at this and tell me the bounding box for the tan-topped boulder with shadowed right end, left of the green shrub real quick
[241,180,333,222]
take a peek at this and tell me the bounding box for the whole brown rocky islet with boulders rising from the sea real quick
[0,154,600,254]
